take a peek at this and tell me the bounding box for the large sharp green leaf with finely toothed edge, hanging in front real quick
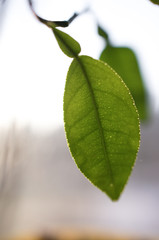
[64,56,140,200]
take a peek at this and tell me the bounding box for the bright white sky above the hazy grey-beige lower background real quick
[0,0,159,130]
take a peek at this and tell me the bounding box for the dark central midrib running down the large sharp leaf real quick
[76,56,115,193]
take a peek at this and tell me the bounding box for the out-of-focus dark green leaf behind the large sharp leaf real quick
[98,27,147,120]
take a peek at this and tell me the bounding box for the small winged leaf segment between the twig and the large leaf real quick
[52,28,81,58]
